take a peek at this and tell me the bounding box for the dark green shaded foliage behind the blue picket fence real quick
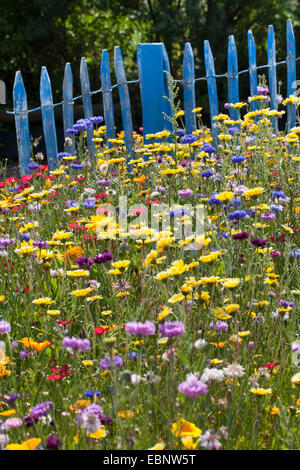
[0,0,300,157]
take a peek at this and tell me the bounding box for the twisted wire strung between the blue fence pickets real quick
[6,57,300,116]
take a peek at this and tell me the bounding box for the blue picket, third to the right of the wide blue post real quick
[227,35,239,121]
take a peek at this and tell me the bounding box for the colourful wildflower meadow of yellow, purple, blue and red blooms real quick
[0,93,300,450]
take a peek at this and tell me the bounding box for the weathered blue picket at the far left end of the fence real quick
[13,71,32,176]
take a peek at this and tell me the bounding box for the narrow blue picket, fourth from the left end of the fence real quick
[80,57,95,158]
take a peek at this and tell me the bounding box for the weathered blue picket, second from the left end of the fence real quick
[40,67,59,170]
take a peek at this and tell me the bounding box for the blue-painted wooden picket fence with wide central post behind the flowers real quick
[10,20,300,175]
